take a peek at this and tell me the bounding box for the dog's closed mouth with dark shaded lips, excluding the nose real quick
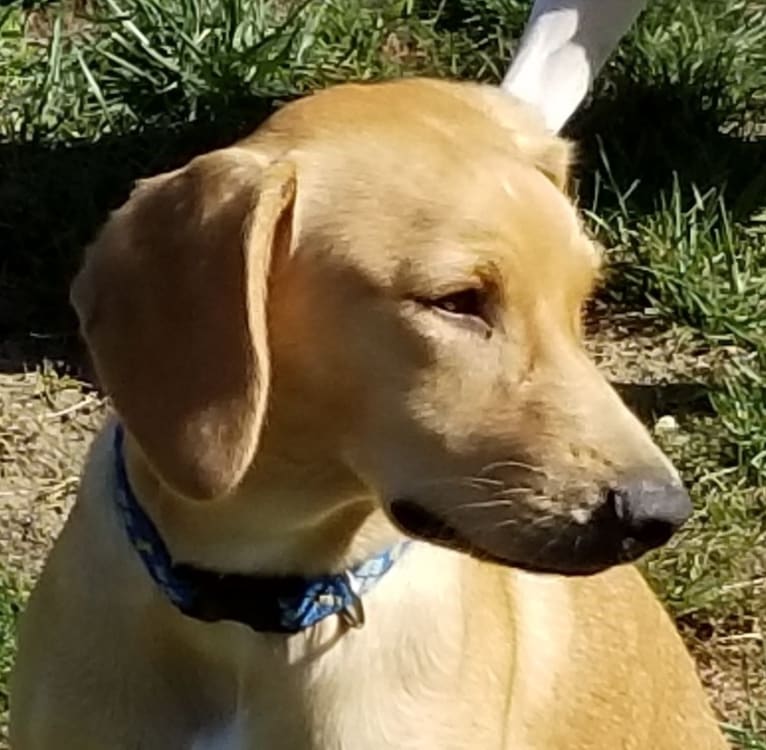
[388,498,664,576]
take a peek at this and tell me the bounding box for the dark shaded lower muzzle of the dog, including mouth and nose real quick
[388,476,692,575]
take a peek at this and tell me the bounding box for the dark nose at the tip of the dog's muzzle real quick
[608,479,692,548]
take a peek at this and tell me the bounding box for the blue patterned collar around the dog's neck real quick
[114,425,409,633]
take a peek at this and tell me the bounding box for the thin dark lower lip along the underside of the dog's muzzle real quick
[387,498,649,576]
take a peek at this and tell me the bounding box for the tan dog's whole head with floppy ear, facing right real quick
[73,80,690,573]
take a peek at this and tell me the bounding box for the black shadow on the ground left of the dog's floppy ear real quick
[0,101,271,373]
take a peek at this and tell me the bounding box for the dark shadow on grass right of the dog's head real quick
[566,80,766,221]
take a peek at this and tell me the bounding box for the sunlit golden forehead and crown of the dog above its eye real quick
[262,81,587,283]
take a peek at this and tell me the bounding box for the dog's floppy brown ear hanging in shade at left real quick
[71,148,295,499]
